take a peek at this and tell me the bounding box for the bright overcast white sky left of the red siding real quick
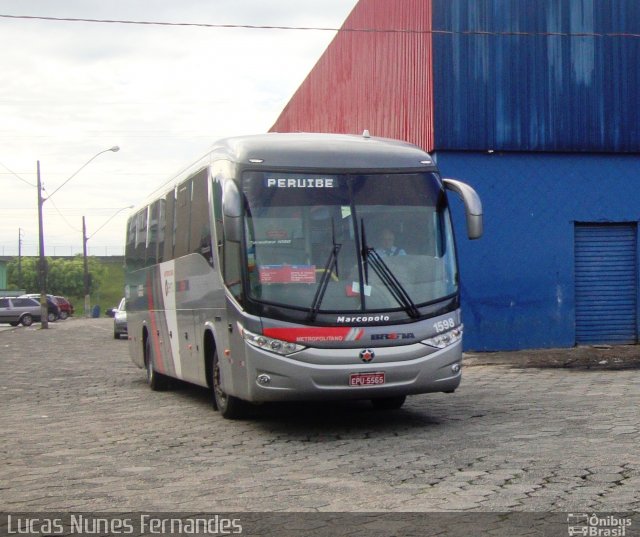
[0,0,357,255]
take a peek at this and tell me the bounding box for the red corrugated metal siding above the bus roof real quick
[271,0,433,150]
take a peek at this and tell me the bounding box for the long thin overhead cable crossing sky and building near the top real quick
[0,14,640,38]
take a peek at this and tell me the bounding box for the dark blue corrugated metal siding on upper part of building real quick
[432,0,640,152]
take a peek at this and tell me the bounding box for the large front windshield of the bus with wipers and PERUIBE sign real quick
[242,171,458,317]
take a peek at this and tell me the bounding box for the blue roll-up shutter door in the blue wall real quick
[575,223,638,344]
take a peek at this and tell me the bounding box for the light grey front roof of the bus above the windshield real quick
[211,133,435,169]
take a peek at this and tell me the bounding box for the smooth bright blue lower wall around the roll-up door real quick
[436,152,640,351]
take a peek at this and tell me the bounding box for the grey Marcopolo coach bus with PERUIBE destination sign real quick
[125,131,482,419]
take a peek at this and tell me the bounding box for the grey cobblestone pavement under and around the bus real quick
[0,319,640,512]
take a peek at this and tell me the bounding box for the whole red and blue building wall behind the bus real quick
[272,0,640,350]
